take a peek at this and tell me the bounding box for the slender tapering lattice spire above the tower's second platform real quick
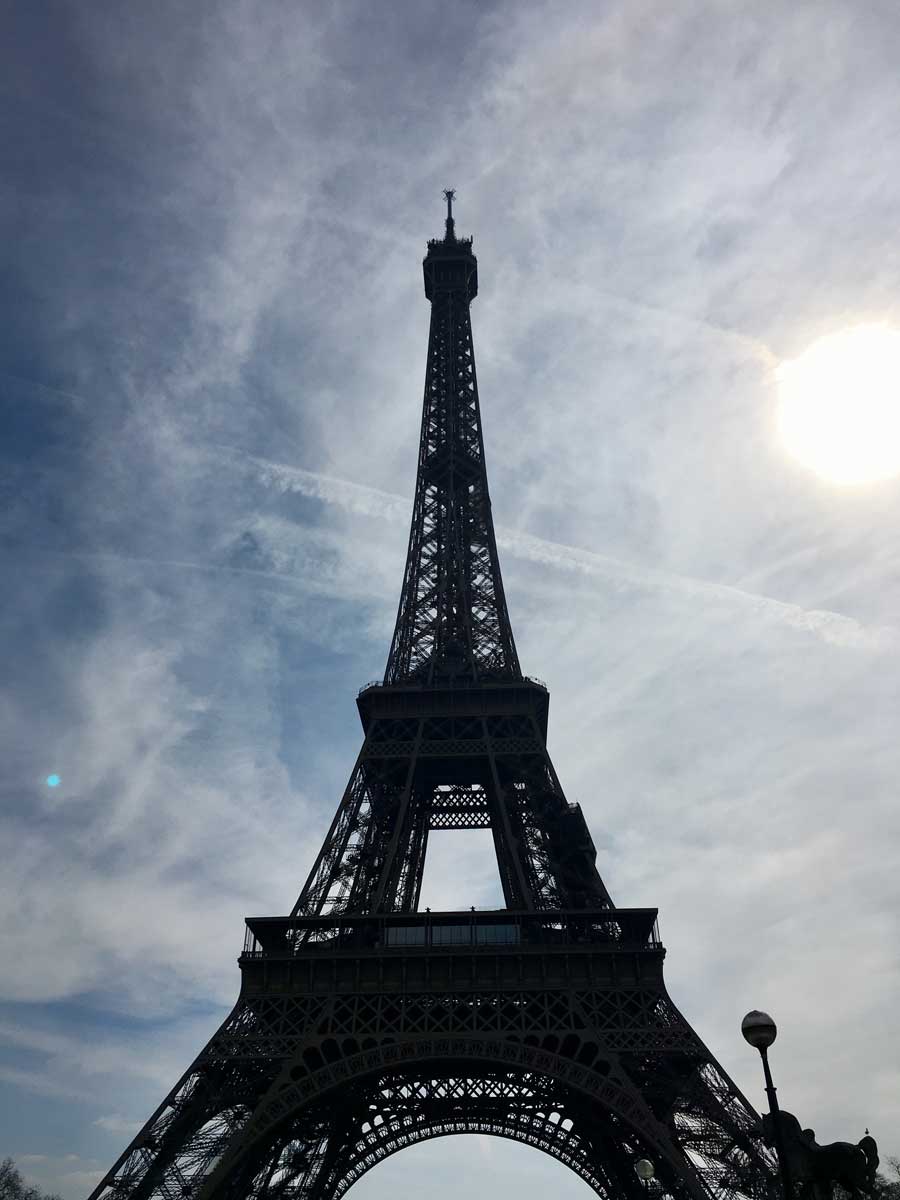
[384,230,520,684]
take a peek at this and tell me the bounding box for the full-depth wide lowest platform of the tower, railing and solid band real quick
[239,908,666,996]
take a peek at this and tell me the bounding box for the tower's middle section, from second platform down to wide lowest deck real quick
[294,700,611,916]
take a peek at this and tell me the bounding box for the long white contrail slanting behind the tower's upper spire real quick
[220,446,900,649]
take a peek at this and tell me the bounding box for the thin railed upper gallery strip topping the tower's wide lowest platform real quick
[244,908,661,958]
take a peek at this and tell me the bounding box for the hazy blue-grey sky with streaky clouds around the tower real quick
[0,0,900,1200]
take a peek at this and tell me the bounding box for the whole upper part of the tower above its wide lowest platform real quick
[294,213,611,916]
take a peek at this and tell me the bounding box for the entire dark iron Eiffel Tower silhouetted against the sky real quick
[91,191,776,1200]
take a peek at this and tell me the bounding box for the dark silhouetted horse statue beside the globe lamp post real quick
[762,1109,878,1200]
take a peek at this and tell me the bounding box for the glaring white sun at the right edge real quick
[775,325,900,484]
